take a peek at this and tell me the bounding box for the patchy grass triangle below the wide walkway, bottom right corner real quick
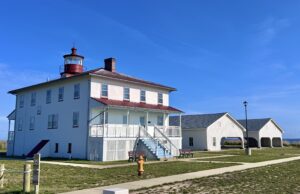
[133,160,300,194]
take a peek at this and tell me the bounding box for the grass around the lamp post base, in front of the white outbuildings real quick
[199,147,300,162]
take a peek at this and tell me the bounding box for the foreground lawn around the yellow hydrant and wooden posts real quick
[0,160,236,193]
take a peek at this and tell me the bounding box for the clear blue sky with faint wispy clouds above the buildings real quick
[0,0,300,139]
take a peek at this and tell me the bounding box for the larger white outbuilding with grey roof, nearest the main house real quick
[170,113,245,151]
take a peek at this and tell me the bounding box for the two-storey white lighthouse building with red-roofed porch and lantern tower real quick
[7,48,182,161]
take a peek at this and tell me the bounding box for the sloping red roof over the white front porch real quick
[92,98,182,112]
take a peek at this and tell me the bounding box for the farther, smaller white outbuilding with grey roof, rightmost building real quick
[238,118,283,147]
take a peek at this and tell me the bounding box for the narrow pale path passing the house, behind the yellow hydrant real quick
[41,155,233,169]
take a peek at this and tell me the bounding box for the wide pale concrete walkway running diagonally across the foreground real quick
[61,156,300,194]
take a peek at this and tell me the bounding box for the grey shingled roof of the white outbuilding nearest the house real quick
[169,113,228,129]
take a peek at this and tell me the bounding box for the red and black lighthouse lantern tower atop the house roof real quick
[60,47,84,77]
